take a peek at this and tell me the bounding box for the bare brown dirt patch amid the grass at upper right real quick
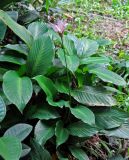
[89,14,129,40]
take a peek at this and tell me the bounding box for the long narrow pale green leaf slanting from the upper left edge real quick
[0,10,33,48]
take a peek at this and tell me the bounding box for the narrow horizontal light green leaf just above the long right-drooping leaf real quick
[80,57,110,64]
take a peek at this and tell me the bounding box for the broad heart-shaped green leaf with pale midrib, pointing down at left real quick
[3,71,33,112]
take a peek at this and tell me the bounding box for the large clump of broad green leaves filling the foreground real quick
[0,10,129,160]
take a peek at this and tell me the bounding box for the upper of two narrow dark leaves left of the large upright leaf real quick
[4,44,28,55]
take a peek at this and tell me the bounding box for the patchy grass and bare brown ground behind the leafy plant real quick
[54,0,129,57]
